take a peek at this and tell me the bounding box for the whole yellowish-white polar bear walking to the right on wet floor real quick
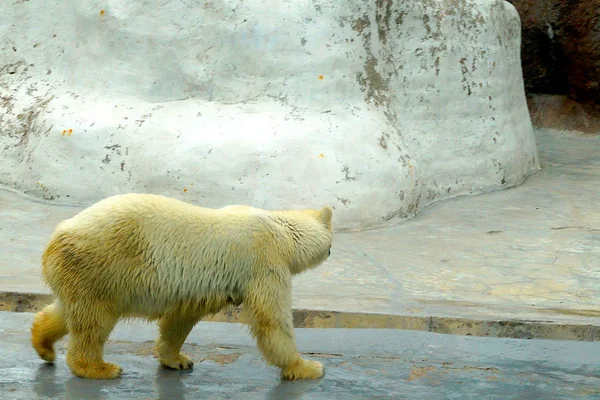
[32,194,332,379]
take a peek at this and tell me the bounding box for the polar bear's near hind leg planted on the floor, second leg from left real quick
[67,303,122,379]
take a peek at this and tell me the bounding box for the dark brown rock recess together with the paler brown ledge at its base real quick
[509,0,600,133]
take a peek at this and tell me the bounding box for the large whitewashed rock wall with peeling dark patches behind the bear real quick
[0,0,539,229]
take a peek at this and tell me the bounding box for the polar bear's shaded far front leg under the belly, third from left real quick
[154,313,202,369]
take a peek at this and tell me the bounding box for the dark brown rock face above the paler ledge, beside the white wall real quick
[509,0,600,103]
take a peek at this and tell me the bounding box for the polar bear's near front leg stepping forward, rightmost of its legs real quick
[244,270,325,380]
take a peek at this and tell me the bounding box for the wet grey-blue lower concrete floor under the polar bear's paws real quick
[0,313,600,400]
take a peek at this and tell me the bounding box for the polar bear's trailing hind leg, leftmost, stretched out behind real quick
[31,300,69,363]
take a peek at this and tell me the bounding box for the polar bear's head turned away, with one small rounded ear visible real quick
[288,206,333,274]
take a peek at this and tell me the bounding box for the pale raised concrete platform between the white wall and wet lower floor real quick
[0,130,600,334]
